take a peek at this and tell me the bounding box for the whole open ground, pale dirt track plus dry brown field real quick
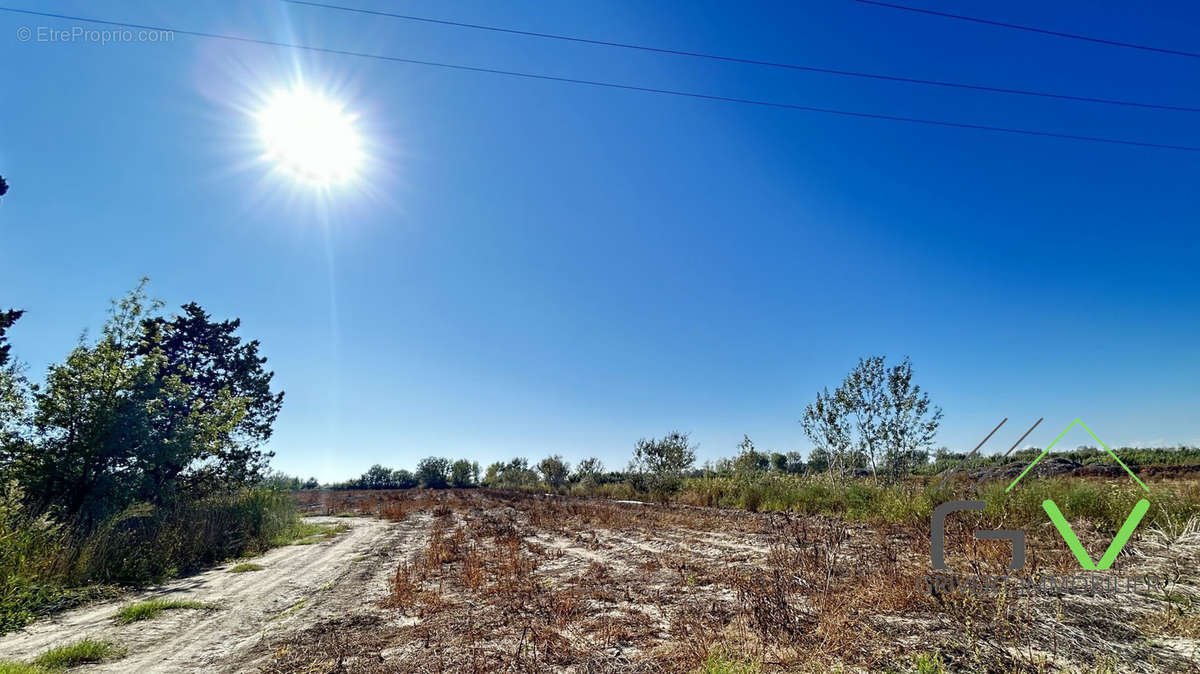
[0,489,1200,673]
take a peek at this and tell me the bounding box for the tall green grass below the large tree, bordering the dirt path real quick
[0,486,301,633]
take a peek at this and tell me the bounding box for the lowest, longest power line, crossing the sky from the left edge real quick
[0,6,1200,152]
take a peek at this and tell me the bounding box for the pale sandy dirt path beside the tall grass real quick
[0,517,419,672]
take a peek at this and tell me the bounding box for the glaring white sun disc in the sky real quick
[256,89,362,186]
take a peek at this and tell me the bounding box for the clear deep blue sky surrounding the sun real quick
[0,0,1200,480]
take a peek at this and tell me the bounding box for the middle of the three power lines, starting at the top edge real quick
[282,0,1200,113]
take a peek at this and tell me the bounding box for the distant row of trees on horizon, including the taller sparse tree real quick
[290,356,947,494]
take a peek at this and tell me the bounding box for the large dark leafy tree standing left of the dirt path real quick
[10,279,282,526]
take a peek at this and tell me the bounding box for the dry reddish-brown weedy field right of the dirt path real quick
[276,479,1200,673]
